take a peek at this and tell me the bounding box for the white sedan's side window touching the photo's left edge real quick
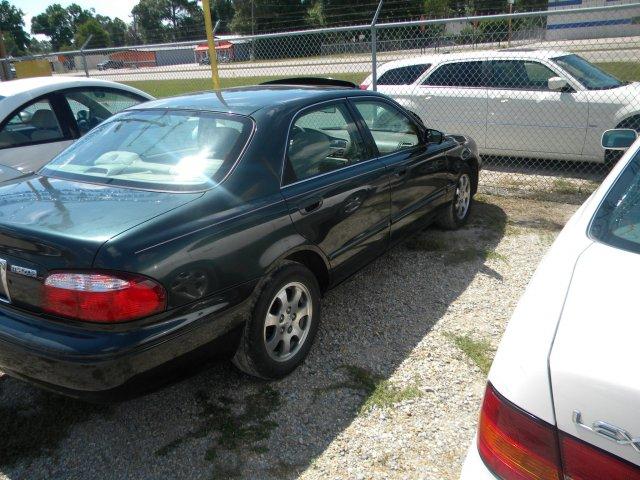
[0,99,64,148]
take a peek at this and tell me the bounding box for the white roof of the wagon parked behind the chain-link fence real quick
[380,48,571,71]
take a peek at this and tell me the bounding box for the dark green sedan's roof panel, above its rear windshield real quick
[129,85,383,115]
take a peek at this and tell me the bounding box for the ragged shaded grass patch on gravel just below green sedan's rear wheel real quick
[155,385,281,470]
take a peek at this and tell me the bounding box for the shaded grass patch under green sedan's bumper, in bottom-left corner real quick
[0,390,111,467]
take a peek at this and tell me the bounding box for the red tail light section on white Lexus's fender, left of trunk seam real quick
[478,384,562,480]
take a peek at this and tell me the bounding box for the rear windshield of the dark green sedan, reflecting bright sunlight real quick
[40,110,252,190]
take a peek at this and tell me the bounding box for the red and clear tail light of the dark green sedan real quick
[42,272,166,323]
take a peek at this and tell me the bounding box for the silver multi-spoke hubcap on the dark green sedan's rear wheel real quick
[264,282,313,362]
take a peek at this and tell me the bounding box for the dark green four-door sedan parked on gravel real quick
[0,85,480,398]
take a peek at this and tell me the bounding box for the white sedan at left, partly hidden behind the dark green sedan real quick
[0,77,153,171]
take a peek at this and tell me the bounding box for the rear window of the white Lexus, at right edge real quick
[590,146,640,253]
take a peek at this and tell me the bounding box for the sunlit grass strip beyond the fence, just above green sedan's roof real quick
[122,72,368,98]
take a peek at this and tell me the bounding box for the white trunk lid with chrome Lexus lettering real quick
[549,243,640,465]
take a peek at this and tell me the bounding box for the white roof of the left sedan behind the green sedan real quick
[0,76,153,99]
